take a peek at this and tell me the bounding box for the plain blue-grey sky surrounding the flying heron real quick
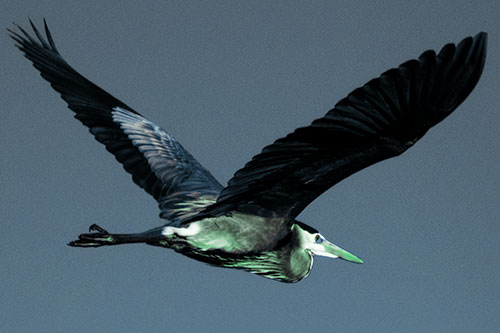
[0,0,500,332]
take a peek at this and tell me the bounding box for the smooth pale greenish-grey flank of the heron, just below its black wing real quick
[167,213,285,253]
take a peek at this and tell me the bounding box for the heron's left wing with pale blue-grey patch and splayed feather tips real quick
[9,20,222,224]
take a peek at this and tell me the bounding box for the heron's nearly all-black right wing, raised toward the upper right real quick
[203,32,487,220]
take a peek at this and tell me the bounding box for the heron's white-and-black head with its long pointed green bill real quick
[292,221,363,264]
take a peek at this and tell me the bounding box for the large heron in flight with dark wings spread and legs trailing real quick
[8,20,487,282]
